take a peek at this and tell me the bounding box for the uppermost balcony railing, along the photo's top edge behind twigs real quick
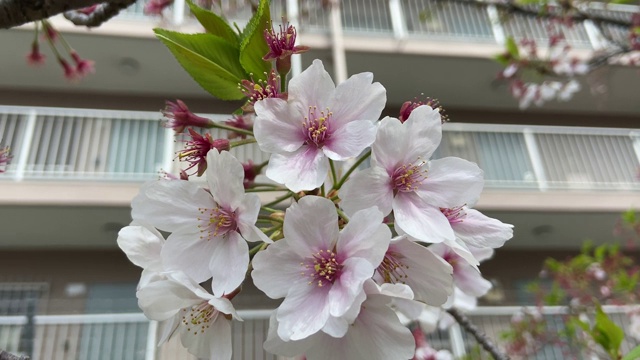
[115,0,638,49]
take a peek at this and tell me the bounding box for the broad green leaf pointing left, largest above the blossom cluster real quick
[153,29,247,100]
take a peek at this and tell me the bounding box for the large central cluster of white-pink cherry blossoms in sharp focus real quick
[118,60,513,360]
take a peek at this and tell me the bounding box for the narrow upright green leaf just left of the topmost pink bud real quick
[240,0,271,81]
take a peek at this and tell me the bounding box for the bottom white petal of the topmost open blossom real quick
[266,145,329,192]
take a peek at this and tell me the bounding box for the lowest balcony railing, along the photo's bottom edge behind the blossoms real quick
[0,306,639,360]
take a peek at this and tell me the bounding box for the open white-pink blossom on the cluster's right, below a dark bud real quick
[340,106,484,242]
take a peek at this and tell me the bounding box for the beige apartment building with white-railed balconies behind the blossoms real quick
[0,0,640,359]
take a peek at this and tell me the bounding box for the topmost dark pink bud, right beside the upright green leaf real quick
[262,23,309,76]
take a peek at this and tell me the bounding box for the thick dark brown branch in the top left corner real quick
[0,0,109,29]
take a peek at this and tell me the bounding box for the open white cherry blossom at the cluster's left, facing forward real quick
[131,151,269,296]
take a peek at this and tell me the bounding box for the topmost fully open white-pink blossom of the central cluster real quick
[254,60,386,192]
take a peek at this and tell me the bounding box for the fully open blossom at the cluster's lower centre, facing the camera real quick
[251,196,391,341]
